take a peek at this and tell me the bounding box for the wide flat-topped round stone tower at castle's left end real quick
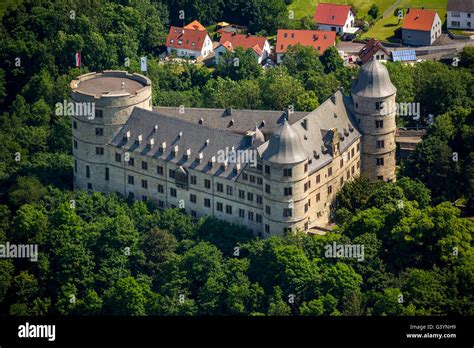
[71,71,152,191]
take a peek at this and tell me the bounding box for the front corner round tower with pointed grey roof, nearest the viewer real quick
[262,120,308,235]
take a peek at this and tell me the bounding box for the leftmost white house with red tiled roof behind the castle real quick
[166,21,213,59]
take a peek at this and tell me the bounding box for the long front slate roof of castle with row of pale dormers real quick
[111,107,251,179]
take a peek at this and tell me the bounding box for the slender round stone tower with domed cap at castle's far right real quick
[352,59,397,181]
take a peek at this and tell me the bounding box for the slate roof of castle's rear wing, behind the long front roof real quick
[153,106,308,138]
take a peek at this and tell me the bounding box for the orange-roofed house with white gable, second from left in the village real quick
[214,31,270,63]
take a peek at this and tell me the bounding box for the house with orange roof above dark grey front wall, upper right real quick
[402,8,442,46]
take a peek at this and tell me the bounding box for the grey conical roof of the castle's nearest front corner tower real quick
[262,120,307,164]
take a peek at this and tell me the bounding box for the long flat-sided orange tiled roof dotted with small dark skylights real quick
[275,29,336,63]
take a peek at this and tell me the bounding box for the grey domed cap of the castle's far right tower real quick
[352,58,397,98]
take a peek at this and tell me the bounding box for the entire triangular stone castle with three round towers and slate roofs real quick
[71,60,396,237]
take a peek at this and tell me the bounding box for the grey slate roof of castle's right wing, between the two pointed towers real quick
[259,91,361,172]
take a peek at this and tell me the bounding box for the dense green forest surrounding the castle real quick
[0,0,474,316]
